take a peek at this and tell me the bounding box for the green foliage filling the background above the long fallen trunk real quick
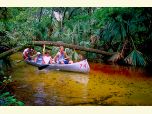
[0,7,152,66]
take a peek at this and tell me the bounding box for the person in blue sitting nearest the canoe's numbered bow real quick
[54,46,73,64]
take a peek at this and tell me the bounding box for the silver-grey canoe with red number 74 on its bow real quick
[26,59,90,73]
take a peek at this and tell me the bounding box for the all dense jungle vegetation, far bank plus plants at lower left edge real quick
[0,7,152,105]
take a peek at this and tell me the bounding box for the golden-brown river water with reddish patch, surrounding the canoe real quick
[11,53,152,106]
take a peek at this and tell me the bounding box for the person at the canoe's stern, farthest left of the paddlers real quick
[23,46,36,60]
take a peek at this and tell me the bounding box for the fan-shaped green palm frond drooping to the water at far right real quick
[125,50,146,66]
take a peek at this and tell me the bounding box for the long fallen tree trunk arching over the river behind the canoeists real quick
[32,41,115,56]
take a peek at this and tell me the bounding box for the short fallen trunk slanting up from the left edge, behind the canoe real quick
[0,45,27,59]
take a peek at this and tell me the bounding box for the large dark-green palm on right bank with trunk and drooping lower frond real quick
[95,8,146,66]
